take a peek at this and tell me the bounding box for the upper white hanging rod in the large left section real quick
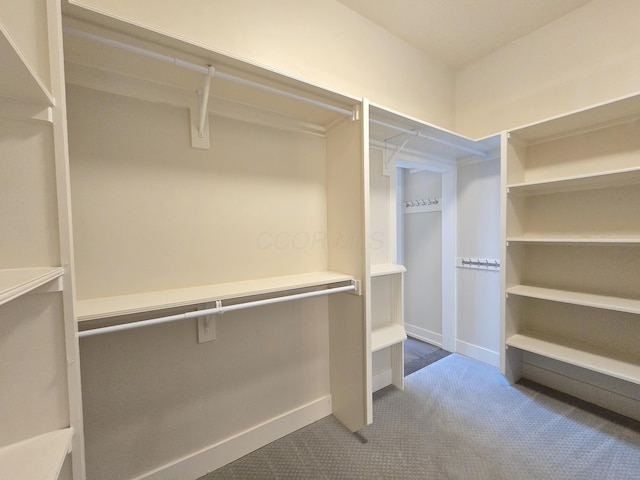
[63,26,357,120]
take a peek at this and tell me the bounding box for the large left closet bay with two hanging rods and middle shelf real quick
[63,2,372,478]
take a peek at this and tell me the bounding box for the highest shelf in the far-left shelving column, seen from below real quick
[0,23,55,106]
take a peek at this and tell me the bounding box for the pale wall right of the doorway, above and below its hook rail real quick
[456,159,500,366]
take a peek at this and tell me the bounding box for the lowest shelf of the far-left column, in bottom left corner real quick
[0,428,73,480]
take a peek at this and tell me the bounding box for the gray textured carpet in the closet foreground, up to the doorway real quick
[201,354,640,480]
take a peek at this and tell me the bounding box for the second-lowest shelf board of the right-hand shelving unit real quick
[506,285,640,314]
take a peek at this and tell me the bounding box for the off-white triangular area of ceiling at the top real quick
[337,0,591,69]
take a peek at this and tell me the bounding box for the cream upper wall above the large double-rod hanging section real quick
[71,0,454,128]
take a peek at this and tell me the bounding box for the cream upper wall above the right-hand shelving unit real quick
[455,0,640,138]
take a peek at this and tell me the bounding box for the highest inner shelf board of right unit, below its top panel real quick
[507,167,640,196]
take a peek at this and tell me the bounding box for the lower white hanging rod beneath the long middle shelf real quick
[78,280,358,338]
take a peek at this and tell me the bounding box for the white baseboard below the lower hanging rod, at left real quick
[133,395,331,480]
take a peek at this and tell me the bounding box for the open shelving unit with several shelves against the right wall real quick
[501,95,640,417]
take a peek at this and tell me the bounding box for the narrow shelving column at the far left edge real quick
[0,0,85,480]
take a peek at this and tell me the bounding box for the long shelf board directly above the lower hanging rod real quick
[76,272,353,322]
